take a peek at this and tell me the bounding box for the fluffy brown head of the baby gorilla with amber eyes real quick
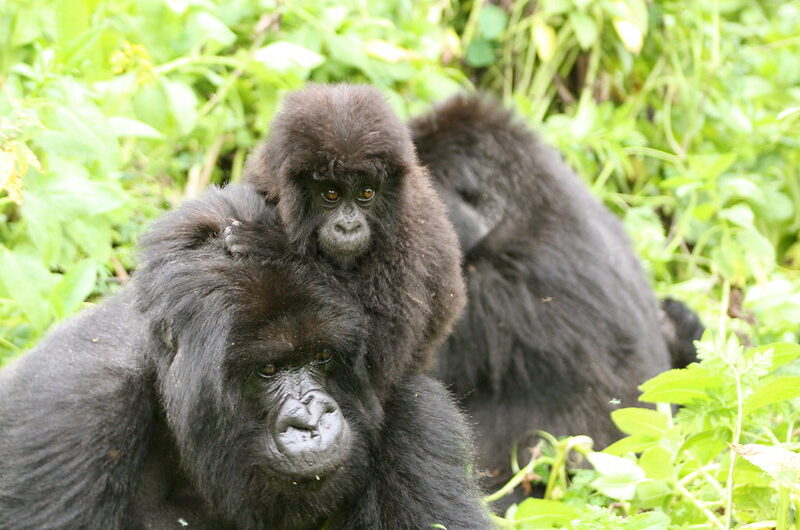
[248,85,419,266]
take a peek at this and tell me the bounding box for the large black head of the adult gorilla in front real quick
[139,233,383,528]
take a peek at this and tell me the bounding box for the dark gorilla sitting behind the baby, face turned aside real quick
[411,96,702,502]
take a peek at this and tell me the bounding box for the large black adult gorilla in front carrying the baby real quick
[0,187,489,530]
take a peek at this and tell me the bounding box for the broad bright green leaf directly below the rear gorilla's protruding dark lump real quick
[639,364,725,405]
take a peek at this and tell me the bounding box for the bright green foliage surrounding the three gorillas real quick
[0,0,800,529]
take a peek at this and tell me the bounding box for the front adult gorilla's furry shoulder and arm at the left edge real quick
[0,290,153,530]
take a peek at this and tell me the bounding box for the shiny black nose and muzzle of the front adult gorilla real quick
[275,391,348,474]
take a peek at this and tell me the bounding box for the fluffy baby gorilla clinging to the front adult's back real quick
[223,85,465,385]
